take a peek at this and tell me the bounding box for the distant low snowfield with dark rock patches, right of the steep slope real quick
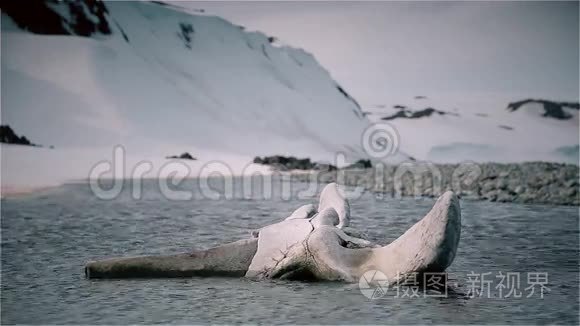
[365,96,580,164]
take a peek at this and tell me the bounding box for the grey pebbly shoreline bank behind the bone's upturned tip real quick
[290,162,580,206]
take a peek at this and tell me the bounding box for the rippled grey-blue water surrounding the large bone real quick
[1,181,579,324]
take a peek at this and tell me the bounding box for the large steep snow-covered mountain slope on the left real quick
[1,1,402,192]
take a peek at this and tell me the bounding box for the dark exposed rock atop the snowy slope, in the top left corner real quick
[0,0,111,36]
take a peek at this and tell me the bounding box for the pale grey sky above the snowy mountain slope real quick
[177,1,580,105]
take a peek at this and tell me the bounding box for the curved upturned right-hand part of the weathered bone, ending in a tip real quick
[307,191,461,282]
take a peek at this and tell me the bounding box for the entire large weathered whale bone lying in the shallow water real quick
[85,183,461,282]
